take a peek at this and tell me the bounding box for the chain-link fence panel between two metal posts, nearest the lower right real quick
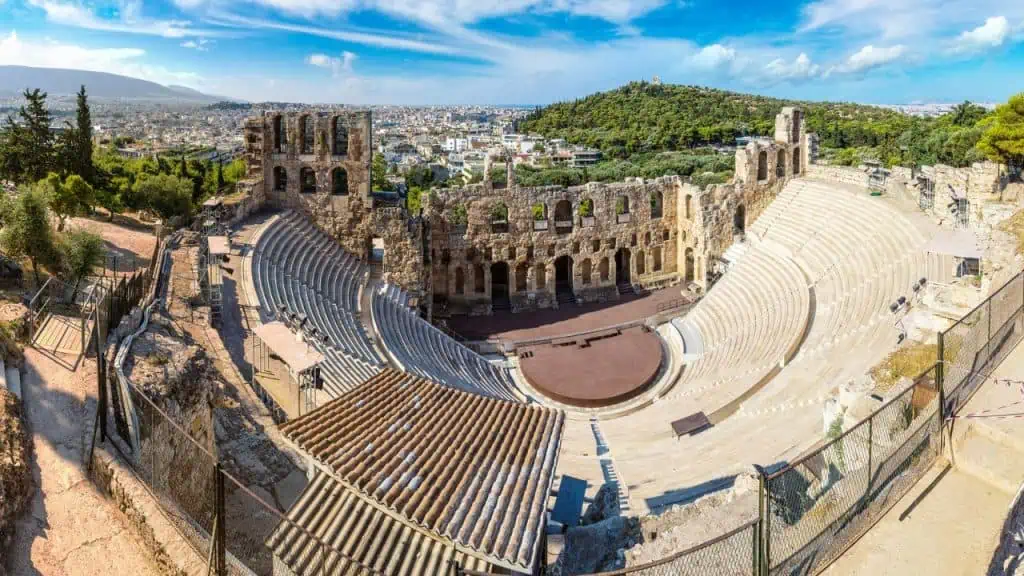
[762,375,941,575]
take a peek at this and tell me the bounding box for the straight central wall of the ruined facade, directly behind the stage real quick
[425,176,682,314]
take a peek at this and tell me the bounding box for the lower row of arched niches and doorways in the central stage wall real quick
[454,246,663,302]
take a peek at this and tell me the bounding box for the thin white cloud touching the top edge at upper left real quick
[28,0,219,38]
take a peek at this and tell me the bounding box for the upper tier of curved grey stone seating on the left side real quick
[252,213,382,398]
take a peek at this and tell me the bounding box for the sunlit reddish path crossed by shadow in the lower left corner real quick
[4,348,159,576]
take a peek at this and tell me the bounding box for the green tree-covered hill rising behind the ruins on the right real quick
[519,82,989,166]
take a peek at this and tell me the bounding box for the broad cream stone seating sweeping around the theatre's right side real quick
[601,178,926,506]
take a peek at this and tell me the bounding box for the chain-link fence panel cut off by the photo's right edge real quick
[939,273,1024,417]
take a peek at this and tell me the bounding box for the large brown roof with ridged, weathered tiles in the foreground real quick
[281,370,564,570]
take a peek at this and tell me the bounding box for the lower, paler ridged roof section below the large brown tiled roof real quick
[266,471,490,576]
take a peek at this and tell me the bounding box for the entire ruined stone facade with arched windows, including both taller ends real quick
[246,108,815,314]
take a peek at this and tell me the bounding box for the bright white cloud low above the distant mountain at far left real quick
[0,31,202,86]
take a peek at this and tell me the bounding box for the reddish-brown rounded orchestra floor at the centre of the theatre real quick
[518,327,663,408]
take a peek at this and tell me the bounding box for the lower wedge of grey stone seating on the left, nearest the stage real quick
[371,285,521,401]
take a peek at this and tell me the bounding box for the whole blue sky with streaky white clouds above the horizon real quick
[0,0,1024,105]
